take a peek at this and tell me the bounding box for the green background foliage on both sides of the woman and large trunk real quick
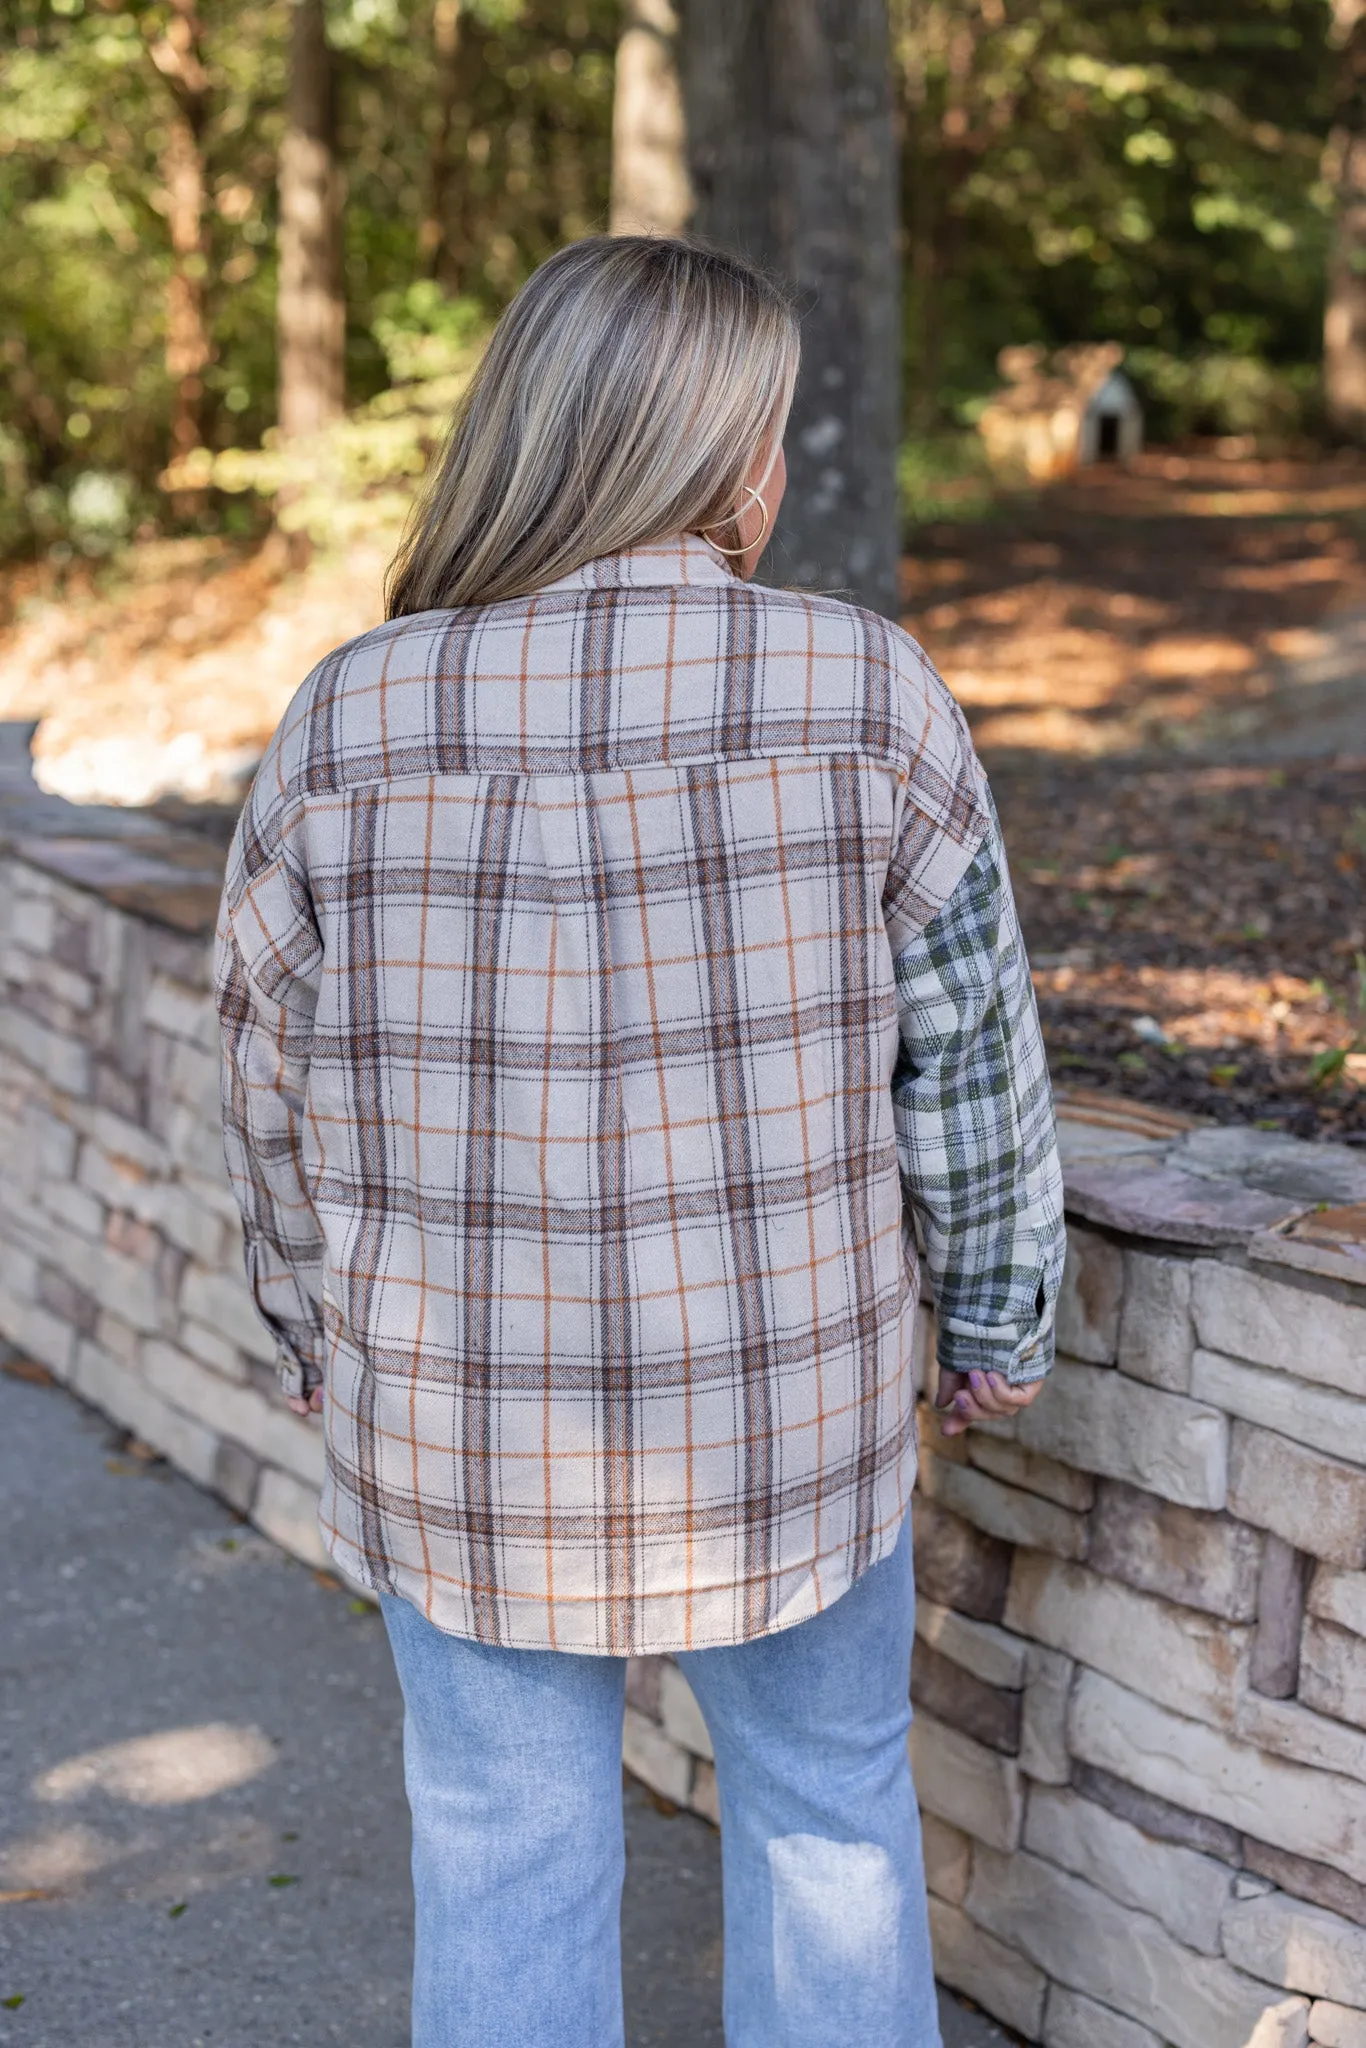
[0,0,1341,555]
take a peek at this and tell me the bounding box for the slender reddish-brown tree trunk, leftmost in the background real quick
[150,0,213,459]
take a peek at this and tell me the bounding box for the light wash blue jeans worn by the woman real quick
[383,1516,940,2048]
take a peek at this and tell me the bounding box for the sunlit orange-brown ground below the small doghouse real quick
[903,455,1366,758]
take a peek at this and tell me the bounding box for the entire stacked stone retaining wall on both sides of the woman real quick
[0,729,1366,2048]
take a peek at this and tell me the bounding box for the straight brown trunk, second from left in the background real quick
[276,0,346,436]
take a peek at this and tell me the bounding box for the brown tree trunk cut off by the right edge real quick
[1323,0,1366,440]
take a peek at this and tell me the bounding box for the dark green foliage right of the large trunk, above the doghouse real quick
[893,0,1335,430]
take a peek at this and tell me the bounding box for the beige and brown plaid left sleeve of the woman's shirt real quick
[215,803,324,1395]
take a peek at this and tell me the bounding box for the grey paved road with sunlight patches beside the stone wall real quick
[0,1372,1004,2048]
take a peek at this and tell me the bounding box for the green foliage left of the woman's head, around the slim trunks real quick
[0,0,618,553]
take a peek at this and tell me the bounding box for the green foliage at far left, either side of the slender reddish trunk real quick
[0,0,287,553]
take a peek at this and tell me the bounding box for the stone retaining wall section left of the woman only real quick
[0,725,328,1565]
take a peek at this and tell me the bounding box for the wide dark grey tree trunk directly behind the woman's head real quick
[682,0,901,618]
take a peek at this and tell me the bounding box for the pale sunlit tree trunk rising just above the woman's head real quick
[610,0,692,236]
